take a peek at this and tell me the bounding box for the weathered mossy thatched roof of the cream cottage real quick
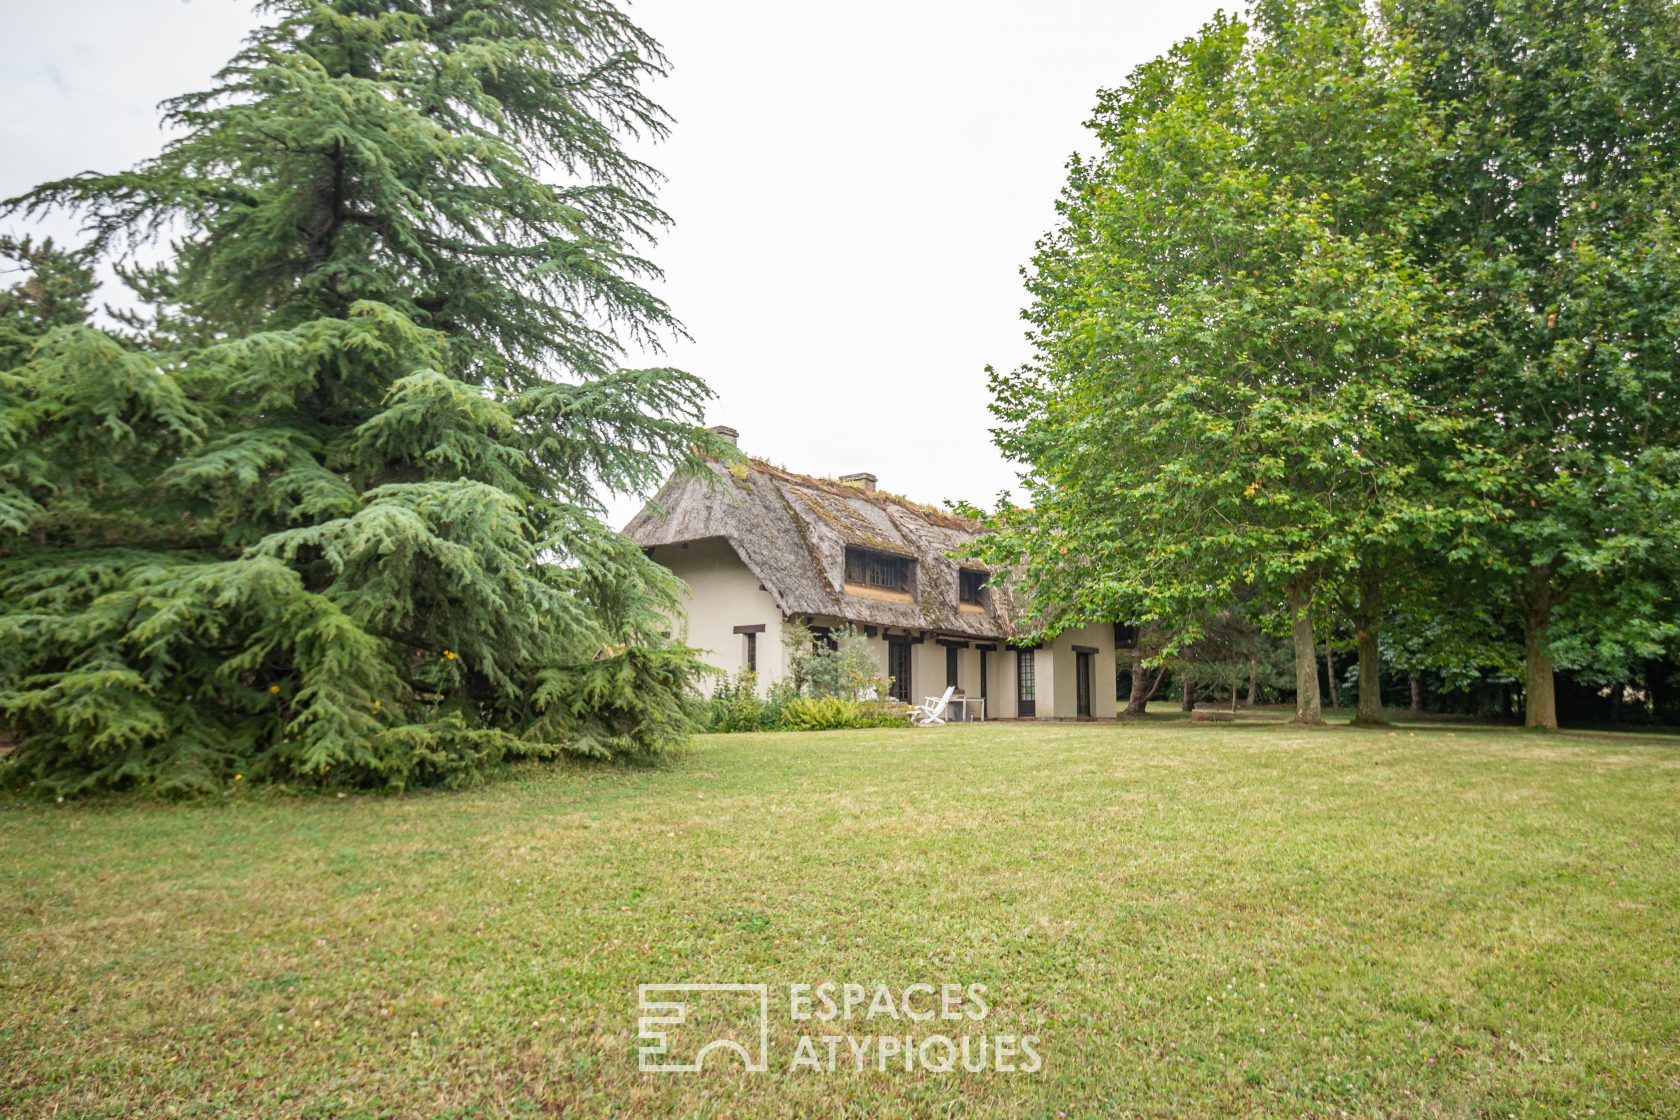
[625,460,1011,638]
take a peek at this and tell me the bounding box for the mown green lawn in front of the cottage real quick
[0,720,1680,1118]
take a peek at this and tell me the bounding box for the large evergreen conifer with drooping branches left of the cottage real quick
[0,0,707,791]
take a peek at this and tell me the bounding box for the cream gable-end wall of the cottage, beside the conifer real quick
[654,537,788,692]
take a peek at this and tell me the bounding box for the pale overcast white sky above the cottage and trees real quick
[0,0,1235,526]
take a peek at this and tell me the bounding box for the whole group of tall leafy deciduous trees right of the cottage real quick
[981,0,1680,727]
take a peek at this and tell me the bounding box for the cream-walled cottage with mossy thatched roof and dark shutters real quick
[625,428,1116,719]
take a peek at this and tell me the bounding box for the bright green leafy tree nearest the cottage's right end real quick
[983,2,1453,719]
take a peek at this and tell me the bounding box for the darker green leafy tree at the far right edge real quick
[1389,0,1680,727]
